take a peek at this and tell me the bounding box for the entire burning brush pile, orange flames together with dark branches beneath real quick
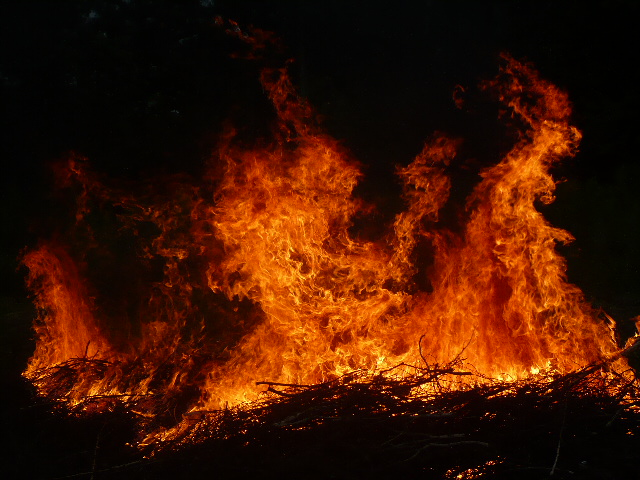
[17,24,639,479]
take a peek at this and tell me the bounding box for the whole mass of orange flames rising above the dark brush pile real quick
[23,37,628,446]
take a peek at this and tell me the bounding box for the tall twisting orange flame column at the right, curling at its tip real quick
[420,57,612,378]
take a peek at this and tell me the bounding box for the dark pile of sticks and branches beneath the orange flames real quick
[20,359,640,479]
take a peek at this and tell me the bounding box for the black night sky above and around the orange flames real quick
[0,0,640,324]
